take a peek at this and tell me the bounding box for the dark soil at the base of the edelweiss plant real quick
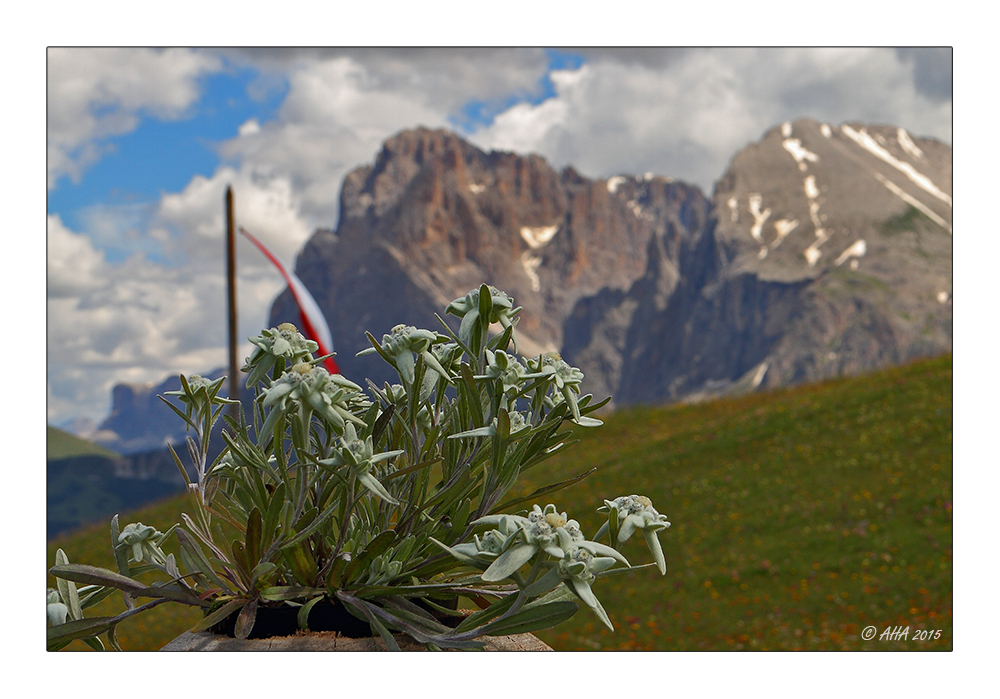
[208,599,460,638]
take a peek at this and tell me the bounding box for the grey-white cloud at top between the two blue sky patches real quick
[212,48,560,227]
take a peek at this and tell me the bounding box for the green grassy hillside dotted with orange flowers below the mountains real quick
[49,356,952,650]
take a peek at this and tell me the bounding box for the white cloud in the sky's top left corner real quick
[47,48,221,189]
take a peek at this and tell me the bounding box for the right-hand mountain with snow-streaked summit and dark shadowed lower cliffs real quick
[563,119,952,404]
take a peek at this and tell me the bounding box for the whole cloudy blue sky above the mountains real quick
[47,48,952,432]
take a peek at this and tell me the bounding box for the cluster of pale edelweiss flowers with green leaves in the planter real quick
[48,285,670,649]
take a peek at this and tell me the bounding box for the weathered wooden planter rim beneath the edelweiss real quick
[160,631,552,652]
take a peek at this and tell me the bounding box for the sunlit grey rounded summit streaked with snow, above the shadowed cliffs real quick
[713,119,951,280]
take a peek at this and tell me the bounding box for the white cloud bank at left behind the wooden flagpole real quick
[46,211,283,422]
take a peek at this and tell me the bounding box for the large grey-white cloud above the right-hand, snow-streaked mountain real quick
[472,48,951,190]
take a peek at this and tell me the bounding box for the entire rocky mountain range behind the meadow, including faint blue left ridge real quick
[90,119,952,453]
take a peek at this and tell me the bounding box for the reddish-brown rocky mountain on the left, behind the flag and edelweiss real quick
[271,129,706,388]
